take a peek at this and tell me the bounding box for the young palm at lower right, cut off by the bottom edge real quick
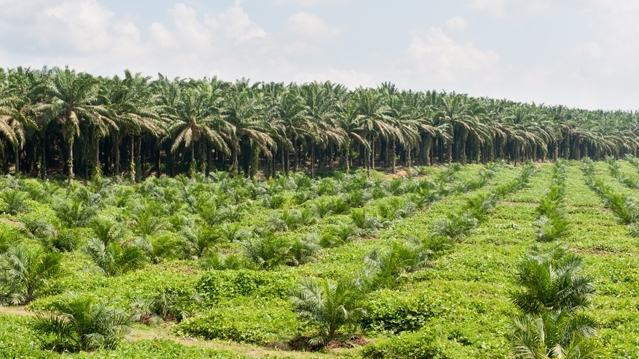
[510,310,601,359]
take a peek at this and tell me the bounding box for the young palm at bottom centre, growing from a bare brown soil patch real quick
[290,279,364,346]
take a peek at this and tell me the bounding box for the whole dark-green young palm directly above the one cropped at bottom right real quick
[512,245,594,314]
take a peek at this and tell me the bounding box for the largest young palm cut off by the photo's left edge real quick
[0,243,62,305]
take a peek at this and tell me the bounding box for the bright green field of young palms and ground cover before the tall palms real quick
[0,161,639,358]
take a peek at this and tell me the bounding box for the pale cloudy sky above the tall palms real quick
[0,0,639,110]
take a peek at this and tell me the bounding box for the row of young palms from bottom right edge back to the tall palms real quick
[509,161,601,359]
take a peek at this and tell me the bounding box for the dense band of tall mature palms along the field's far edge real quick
[0,68,639,181]
